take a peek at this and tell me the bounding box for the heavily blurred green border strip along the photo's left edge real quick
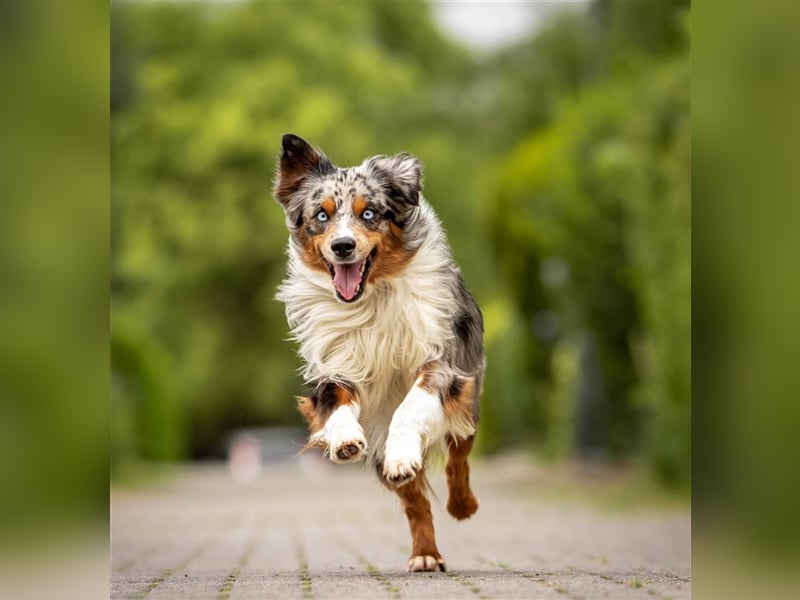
[0,1,109,548]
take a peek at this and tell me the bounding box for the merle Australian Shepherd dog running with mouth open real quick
[273,134,485,571]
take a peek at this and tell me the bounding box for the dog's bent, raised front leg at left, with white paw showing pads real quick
[297,381,367,463]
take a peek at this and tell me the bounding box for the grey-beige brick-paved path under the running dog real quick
[111,455,691,599]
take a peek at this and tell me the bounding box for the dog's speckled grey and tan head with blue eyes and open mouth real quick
[274,134,422,302]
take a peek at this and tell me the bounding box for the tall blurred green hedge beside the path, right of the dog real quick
[490,15,691,482]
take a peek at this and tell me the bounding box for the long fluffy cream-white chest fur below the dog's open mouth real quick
[277,237,457,458]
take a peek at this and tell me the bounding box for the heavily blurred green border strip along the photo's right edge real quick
[692,0,800,556]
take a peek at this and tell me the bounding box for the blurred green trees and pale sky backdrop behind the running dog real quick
[111,0,691,490]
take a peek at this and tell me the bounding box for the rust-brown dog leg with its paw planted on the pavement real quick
[389,471,445,571]
